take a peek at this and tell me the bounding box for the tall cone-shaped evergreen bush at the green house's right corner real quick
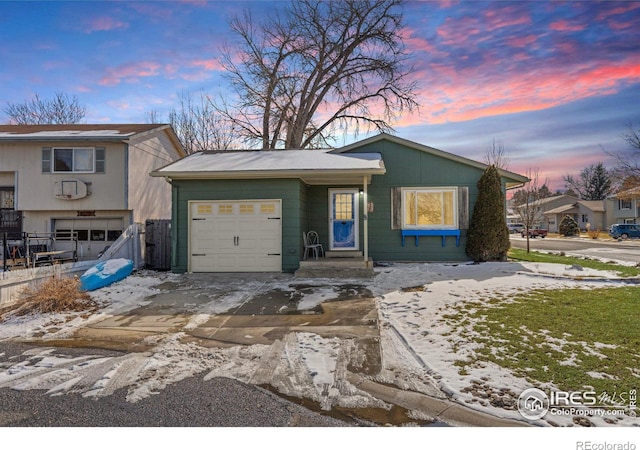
[466,165,511,262]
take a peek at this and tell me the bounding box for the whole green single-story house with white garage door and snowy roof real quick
[151,134,528,272]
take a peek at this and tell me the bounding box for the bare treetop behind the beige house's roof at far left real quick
[4,92,87,125]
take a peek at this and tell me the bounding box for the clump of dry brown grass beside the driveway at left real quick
[0,277,98,320]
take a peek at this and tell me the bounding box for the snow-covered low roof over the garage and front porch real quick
[151,150,386,184]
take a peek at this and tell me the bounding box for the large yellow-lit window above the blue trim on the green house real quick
[402,188,458,229]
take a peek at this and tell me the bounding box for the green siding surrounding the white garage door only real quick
[171,179,307,273]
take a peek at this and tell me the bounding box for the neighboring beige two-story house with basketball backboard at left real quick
[0,124,185,259]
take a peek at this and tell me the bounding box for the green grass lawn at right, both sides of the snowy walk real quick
[445,250,640,404]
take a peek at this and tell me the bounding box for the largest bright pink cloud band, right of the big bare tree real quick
[398,57,640,126]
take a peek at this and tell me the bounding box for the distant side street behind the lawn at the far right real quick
[511,234,640,264]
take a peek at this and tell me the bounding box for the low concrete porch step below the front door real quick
[294,258,375,278]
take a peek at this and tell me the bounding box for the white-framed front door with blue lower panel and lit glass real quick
[329,189,359,250]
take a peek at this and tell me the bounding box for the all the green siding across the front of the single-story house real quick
[172,140,516,272]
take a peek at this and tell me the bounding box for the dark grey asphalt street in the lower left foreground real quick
[0,342,350,427]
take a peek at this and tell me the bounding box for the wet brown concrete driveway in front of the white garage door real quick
[70,273,380,374]
